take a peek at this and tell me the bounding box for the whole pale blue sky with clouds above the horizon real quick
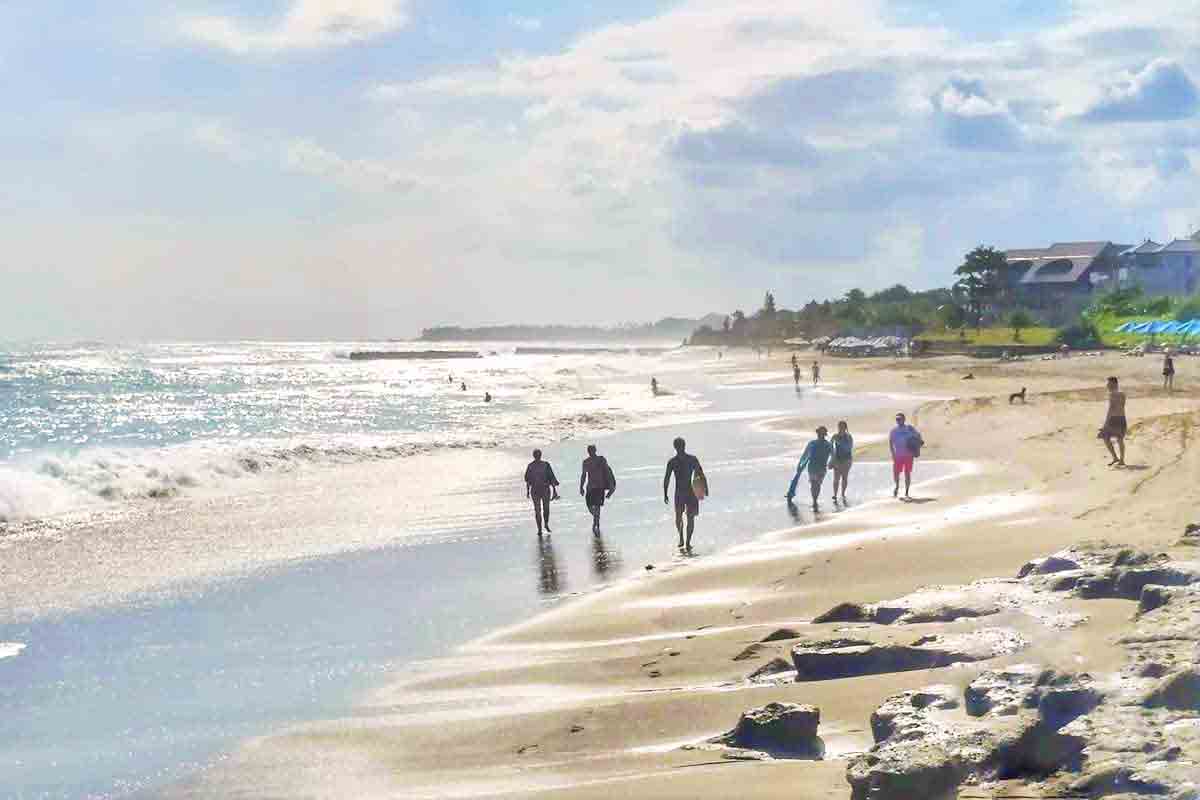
[0,0,1200,341]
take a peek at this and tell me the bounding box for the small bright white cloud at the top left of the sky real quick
[180,0,408,55]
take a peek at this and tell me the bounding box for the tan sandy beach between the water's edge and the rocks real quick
[172,354,1200,800]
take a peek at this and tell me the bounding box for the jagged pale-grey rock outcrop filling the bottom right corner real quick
[835,542,1200,800]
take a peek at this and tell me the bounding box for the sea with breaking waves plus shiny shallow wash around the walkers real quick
[0,343,937,798]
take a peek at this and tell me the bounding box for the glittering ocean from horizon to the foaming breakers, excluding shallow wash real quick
[0,342,690,523]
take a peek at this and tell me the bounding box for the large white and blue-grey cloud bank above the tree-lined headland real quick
[352,0,1195,321]
